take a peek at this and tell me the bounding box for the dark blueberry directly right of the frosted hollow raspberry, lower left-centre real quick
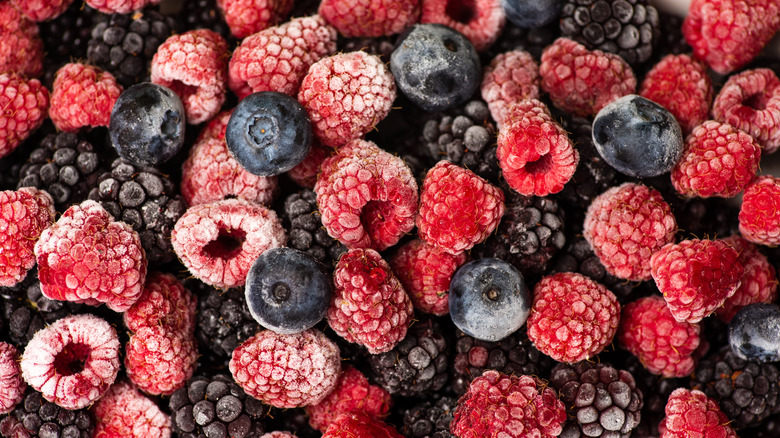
[246,248,330,334]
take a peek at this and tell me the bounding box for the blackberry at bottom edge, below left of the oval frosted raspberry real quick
[168,374,268,438]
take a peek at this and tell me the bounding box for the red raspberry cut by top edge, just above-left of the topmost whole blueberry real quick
[317,0,421,38]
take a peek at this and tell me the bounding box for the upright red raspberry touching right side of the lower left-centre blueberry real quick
[328,249,413,354]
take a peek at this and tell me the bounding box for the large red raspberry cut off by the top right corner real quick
[682,0,780,75]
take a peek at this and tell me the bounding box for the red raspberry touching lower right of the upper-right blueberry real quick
[672,120,760,198]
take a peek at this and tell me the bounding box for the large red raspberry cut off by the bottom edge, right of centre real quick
[450,370,566,438]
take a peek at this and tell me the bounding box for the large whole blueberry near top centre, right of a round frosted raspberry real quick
[390,23,482,111]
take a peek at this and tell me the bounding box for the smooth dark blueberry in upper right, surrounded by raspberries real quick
[593,94,683,178]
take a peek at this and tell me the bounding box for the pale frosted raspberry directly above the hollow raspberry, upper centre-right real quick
[481,50,541,130]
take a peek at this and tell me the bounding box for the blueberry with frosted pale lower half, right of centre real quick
[450,258,531,342]
